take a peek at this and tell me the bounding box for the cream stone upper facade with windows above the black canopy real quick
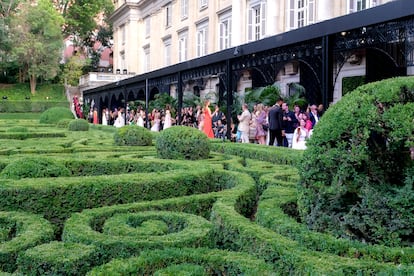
[107,0,390,74]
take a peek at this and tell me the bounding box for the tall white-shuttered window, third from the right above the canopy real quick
[247,0,266,41]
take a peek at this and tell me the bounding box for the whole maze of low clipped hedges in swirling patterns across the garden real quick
[0,121,414,275]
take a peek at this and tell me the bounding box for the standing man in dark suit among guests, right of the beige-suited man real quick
[269,98,284,147]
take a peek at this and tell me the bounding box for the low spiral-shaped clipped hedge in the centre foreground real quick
[63,209,212,259]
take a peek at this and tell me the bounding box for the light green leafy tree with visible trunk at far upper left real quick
[10,0,64,94]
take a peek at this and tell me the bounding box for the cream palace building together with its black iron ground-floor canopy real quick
[84,0,414,124]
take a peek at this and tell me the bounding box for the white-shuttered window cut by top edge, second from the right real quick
[289,0,315,30]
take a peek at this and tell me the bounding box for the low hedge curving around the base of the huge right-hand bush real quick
[256,178,414,264]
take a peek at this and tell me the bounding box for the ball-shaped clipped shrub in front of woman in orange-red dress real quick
[156,126,210,160]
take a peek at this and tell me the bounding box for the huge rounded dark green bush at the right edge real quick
[298,77,414,245]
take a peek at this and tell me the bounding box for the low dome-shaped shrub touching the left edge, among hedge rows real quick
[0,157,70,179]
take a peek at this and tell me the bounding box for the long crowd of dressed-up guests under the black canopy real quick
[81,98,324,149]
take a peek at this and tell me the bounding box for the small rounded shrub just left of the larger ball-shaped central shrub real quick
[114,125,152,146]
